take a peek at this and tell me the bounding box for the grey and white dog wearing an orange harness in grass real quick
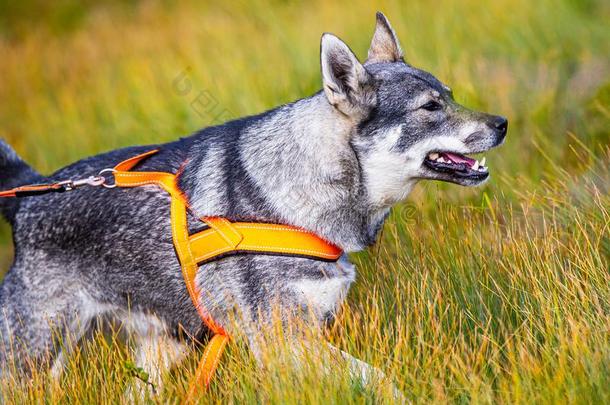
[0,13,507,394]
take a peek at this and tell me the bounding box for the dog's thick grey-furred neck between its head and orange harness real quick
[180,93,402,251]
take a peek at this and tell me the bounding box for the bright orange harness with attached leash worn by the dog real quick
[0,150,342,402]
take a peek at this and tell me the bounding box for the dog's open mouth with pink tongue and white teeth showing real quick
[424,152,489,180]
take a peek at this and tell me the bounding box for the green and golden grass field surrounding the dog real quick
[0,0,610,404]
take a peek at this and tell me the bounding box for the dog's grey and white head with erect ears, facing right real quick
[321,13,507,205]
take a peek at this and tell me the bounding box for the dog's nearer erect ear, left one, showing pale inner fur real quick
[320,34,376,118]
